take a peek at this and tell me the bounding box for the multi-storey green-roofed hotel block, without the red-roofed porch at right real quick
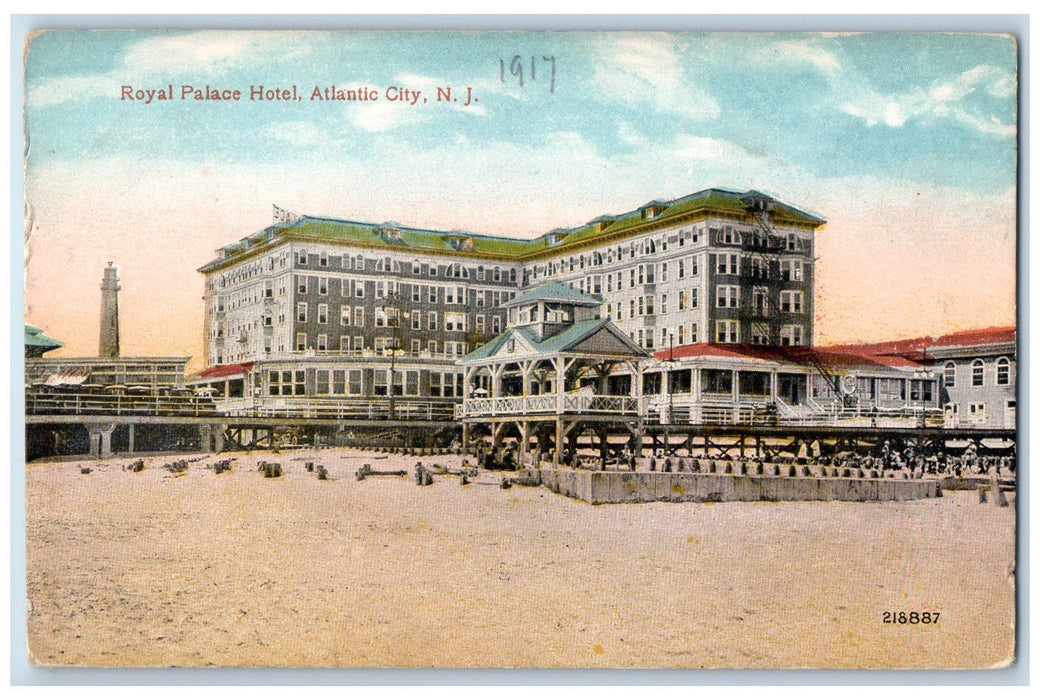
[200,189,825,416]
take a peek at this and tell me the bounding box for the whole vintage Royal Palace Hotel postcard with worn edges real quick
[16,29,1018,670]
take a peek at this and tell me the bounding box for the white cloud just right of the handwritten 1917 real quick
[593,33,720,121]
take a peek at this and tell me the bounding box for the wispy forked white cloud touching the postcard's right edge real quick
[840,66,1017,136]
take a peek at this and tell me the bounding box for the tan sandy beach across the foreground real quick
[26,449,1015,669]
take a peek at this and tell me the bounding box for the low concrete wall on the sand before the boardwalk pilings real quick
[541,469,941,504]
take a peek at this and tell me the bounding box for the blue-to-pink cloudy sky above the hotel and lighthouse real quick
[25,31,1018,369]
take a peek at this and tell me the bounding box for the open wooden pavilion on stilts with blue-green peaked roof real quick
[457,282,649,465]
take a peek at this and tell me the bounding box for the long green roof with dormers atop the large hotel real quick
[200,188,827,273]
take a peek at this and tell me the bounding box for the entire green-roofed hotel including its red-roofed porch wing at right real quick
[198,189,956,422]
